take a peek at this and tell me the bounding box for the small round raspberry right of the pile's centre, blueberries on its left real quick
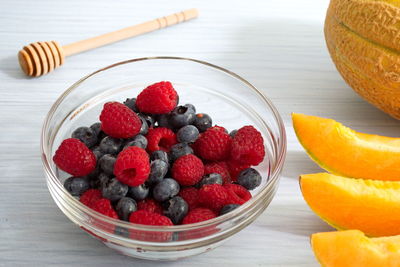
[172,154,204,186]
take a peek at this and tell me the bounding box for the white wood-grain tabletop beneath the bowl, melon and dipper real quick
[0,0,398,266]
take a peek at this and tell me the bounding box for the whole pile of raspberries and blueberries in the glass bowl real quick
[53,82,265,228]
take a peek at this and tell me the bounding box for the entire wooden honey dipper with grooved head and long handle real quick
[18,8,198,77]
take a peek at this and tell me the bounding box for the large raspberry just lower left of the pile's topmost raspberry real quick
[100,102,142,138]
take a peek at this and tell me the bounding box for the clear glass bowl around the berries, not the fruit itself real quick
[41,57,286,260]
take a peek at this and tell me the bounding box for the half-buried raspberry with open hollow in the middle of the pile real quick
[146,127,177,153]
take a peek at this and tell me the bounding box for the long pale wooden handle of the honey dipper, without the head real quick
[63,8,198,56]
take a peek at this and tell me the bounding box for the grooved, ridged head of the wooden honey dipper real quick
[18,41,65,77]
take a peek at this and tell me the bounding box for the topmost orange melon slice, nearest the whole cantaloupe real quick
[292,113,400,181]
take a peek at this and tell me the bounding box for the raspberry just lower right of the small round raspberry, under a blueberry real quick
[199,184,228,212]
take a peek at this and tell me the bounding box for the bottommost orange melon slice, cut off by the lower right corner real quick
[311,230,400,267]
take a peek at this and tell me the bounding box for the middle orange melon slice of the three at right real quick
[300,173,400,236]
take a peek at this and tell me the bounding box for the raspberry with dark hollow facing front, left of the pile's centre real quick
[114,146,150,186]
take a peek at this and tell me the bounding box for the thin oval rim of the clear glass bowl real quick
[40,56,287,232]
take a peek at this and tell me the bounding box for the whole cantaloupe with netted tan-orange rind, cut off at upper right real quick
[324,0,400,119]
